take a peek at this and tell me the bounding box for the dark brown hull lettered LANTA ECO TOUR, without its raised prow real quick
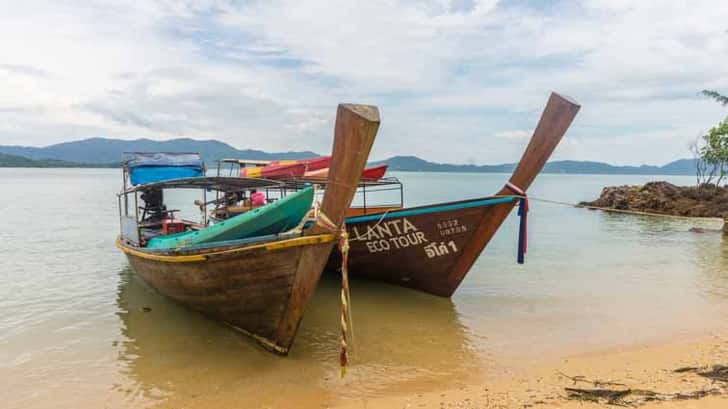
[327,197,514,297]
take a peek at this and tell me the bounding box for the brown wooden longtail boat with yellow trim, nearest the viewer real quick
[117,105,379,354]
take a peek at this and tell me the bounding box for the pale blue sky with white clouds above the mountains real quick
[0,0,728,164]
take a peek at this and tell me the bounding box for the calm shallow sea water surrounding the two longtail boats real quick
[0,169,728,408]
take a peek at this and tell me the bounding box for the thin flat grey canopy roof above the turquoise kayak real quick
[124,176,284,193]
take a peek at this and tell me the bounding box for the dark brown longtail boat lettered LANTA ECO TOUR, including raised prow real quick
[328,93,580,297]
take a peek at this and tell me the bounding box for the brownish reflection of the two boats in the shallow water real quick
[117,268,482,407]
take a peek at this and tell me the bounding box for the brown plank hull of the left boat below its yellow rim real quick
[117,234,335,354]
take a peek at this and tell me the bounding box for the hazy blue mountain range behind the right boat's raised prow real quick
[376,156,695,175]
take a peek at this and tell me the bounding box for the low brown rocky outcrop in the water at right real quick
[579,182,728,218]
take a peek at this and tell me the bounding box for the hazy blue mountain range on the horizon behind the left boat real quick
[0,138,318,164]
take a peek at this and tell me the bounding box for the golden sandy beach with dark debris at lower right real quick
[333,333,728,409]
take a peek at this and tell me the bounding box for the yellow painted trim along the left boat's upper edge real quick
[116,234,336,263]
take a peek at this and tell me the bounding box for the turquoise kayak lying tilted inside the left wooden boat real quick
[147,187,313,249]
